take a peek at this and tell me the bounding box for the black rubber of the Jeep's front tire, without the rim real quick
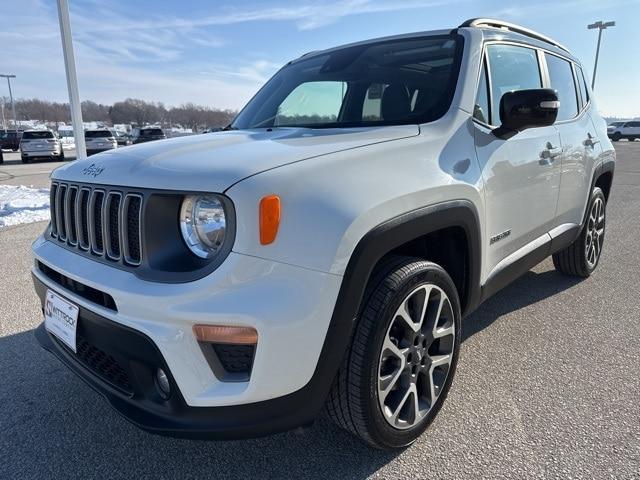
[326,257,461,449]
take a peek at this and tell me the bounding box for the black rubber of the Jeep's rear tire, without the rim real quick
[553,187,607,278]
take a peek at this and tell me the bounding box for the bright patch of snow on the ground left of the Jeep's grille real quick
[0,185,49,228]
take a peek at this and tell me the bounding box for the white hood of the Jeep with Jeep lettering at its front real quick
[52,125,420,192]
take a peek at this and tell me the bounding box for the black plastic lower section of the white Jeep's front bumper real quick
[33,275,332,439]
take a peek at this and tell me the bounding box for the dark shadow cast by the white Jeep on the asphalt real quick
[0,264,577,478]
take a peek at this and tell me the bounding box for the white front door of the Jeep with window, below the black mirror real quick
[474,43,561,280]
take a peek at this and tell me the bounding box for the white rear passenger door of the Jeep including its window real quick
[544,52,602,231]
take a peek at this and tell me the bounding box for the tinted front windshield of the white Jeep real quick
[231,35,462,129]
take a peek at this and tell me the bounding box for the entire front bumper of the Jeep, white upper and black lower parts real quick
[32,237,342,438]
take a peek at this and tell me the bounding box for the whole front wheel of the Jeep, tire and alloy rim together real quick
[327,257,461,449]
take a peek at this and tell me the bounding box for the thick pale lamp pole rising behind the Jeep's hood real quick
[58,0,87,160]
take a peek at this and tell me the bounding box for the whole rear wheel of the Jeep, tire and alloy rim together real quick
[553,187,607,278]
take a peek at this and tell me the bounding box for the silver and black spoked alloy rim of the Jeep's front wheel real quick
[378,284,456,430]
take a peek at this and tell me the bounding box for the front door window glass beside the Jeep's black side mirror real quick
[487,44,542,125]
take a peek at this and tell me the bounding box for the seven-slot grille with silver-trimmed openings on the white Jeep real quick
[50,182,143,266]
